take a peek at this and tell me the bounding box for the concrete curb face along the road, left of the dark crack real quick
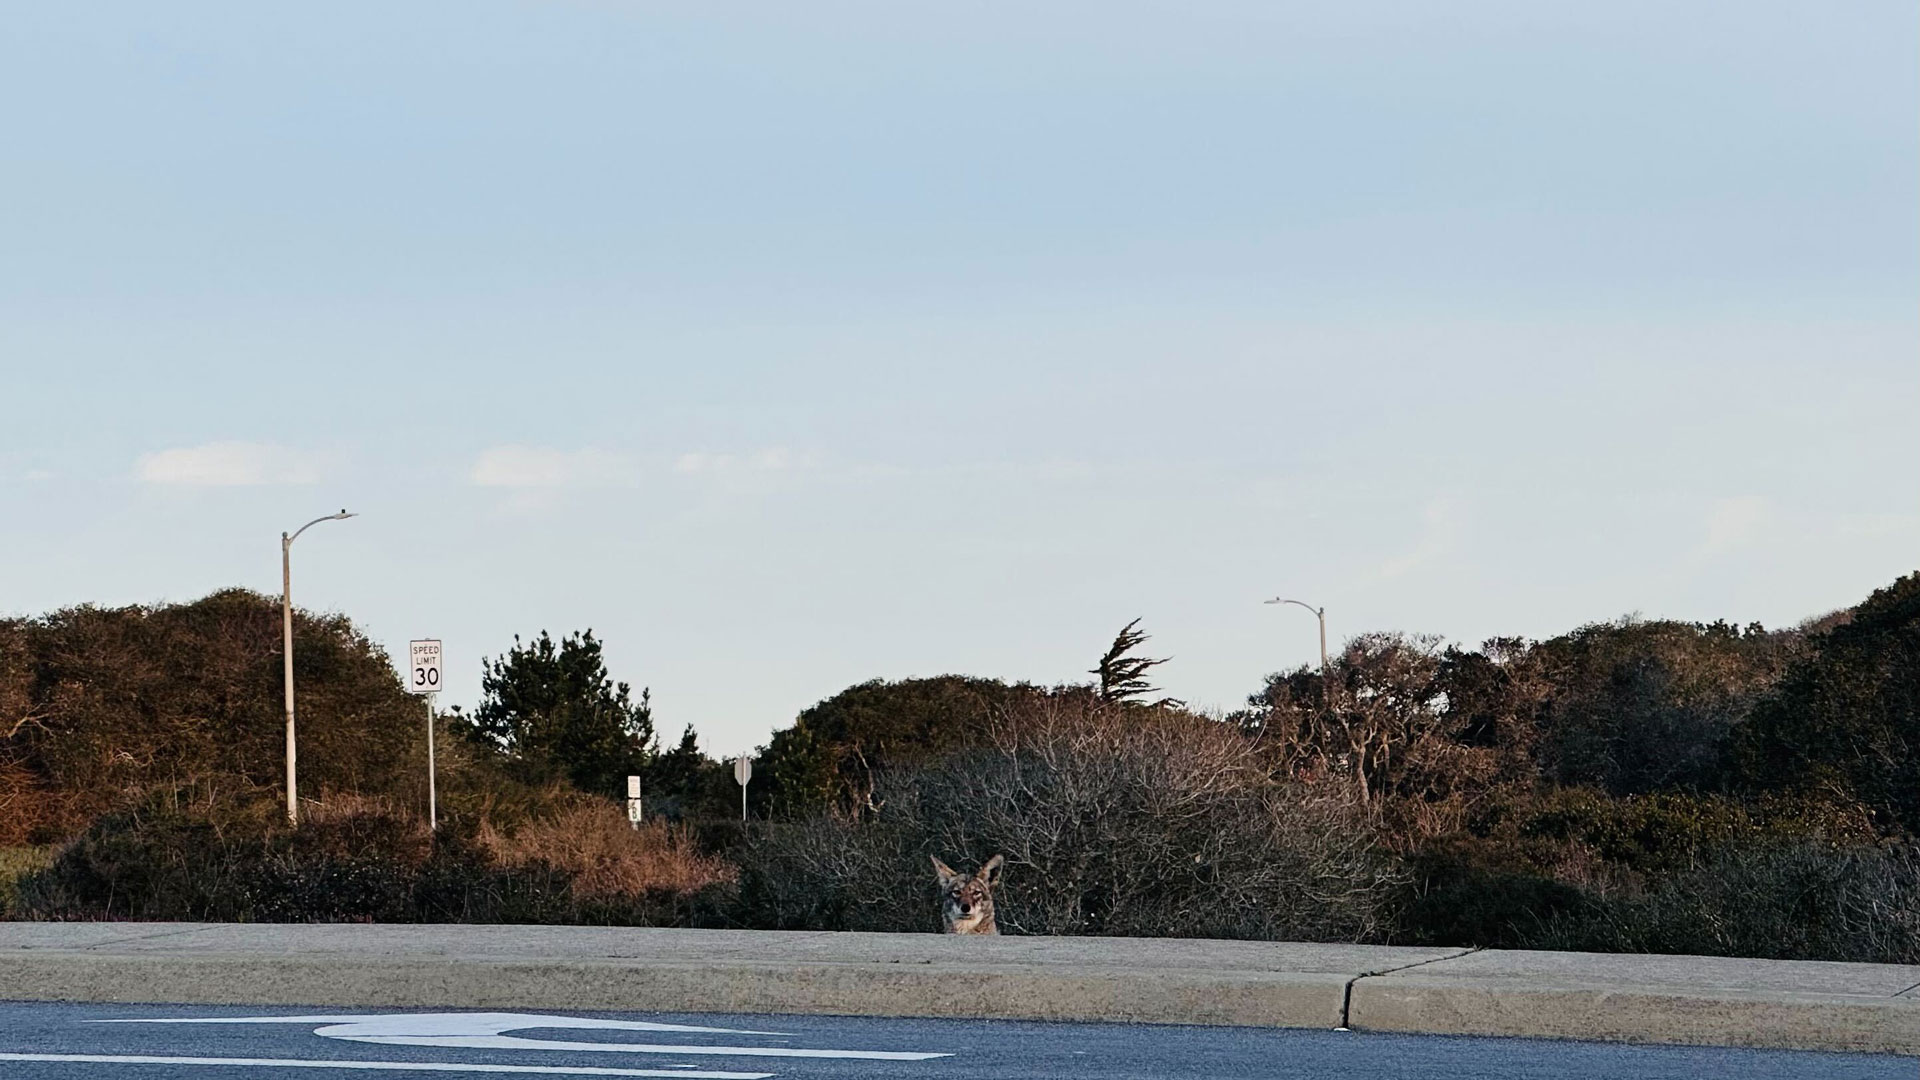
[0,953,1348,1028]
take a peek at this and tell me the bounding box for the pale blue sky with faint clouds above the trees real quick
[0,0,1920,751]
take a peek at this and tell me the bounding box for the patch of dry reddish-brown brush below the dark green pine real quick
[478,798,737,899]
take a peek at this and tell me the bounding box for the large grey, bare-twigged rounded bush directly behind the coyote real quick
[737,698,1400,940]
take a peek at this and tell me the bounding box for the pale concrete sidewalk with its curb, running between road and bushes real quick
[0,922,1920,1055]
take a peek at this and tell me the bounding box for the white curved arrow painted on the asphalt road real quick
[94,1013,952,1076]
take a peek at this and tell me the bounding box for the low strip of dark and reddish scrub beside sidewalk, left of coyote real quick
[17,798,732,926]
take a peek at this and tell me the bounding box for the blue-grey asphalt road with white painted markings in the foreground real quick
[0,1003,1920,1080]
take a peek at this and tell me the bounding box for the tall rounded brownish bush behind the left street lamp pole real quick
[0,588,433,844]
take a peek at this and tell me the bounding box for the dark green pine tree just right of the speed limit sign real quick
[463,630,655,796]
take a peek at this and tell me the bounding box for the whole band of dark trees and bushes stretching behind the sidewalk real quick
[0,575,1920,961]
